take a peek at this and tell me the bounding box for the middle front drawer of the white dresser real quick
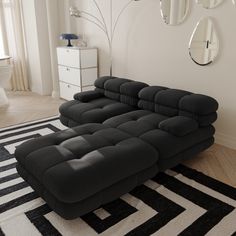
[58,66,81,86]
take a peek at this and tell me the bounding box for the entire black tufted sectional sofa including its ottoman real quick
[15,77,218,219]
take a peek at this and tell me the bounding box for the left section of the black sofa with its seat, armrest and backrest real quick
[59,76,147,127]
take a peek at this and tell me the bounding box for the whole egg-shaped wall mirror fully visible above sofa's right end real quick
[189,17,219,66]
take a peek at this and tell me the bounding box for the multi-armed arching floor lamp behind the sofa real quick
[70,0,140,76]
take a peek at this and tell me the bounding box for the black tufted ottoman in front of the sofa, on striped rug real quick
[15,124,158,219]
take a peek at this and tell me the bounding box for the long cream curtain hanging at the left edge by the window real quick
[0,0,29,91]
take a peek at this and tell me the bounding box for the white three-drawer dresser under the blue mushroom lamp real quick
[57,47,98,100]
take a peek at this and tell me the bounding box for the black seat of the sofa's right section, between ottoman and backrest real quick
[103,110,215,159]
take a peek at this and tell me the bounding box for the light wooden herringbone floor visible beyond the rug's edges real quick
[0,93,236,187]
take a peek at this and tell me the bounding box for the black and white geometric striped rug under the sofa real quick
[0,118,236,236]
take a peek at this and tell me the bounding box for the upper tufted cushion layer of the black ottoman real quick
[15,124,158,203]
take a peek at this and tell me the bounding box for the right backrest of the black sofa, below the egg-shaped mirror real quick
[138,86,218,126]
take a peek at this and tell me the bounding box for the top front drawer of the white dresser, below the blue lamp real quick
[57,48,80,68]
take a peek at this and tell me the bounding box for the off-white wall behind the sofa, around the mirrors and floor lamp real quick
[71,0,236,148]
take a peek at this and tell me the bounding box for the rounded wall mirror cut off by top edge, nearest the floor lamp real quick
[160,0,189,25]
